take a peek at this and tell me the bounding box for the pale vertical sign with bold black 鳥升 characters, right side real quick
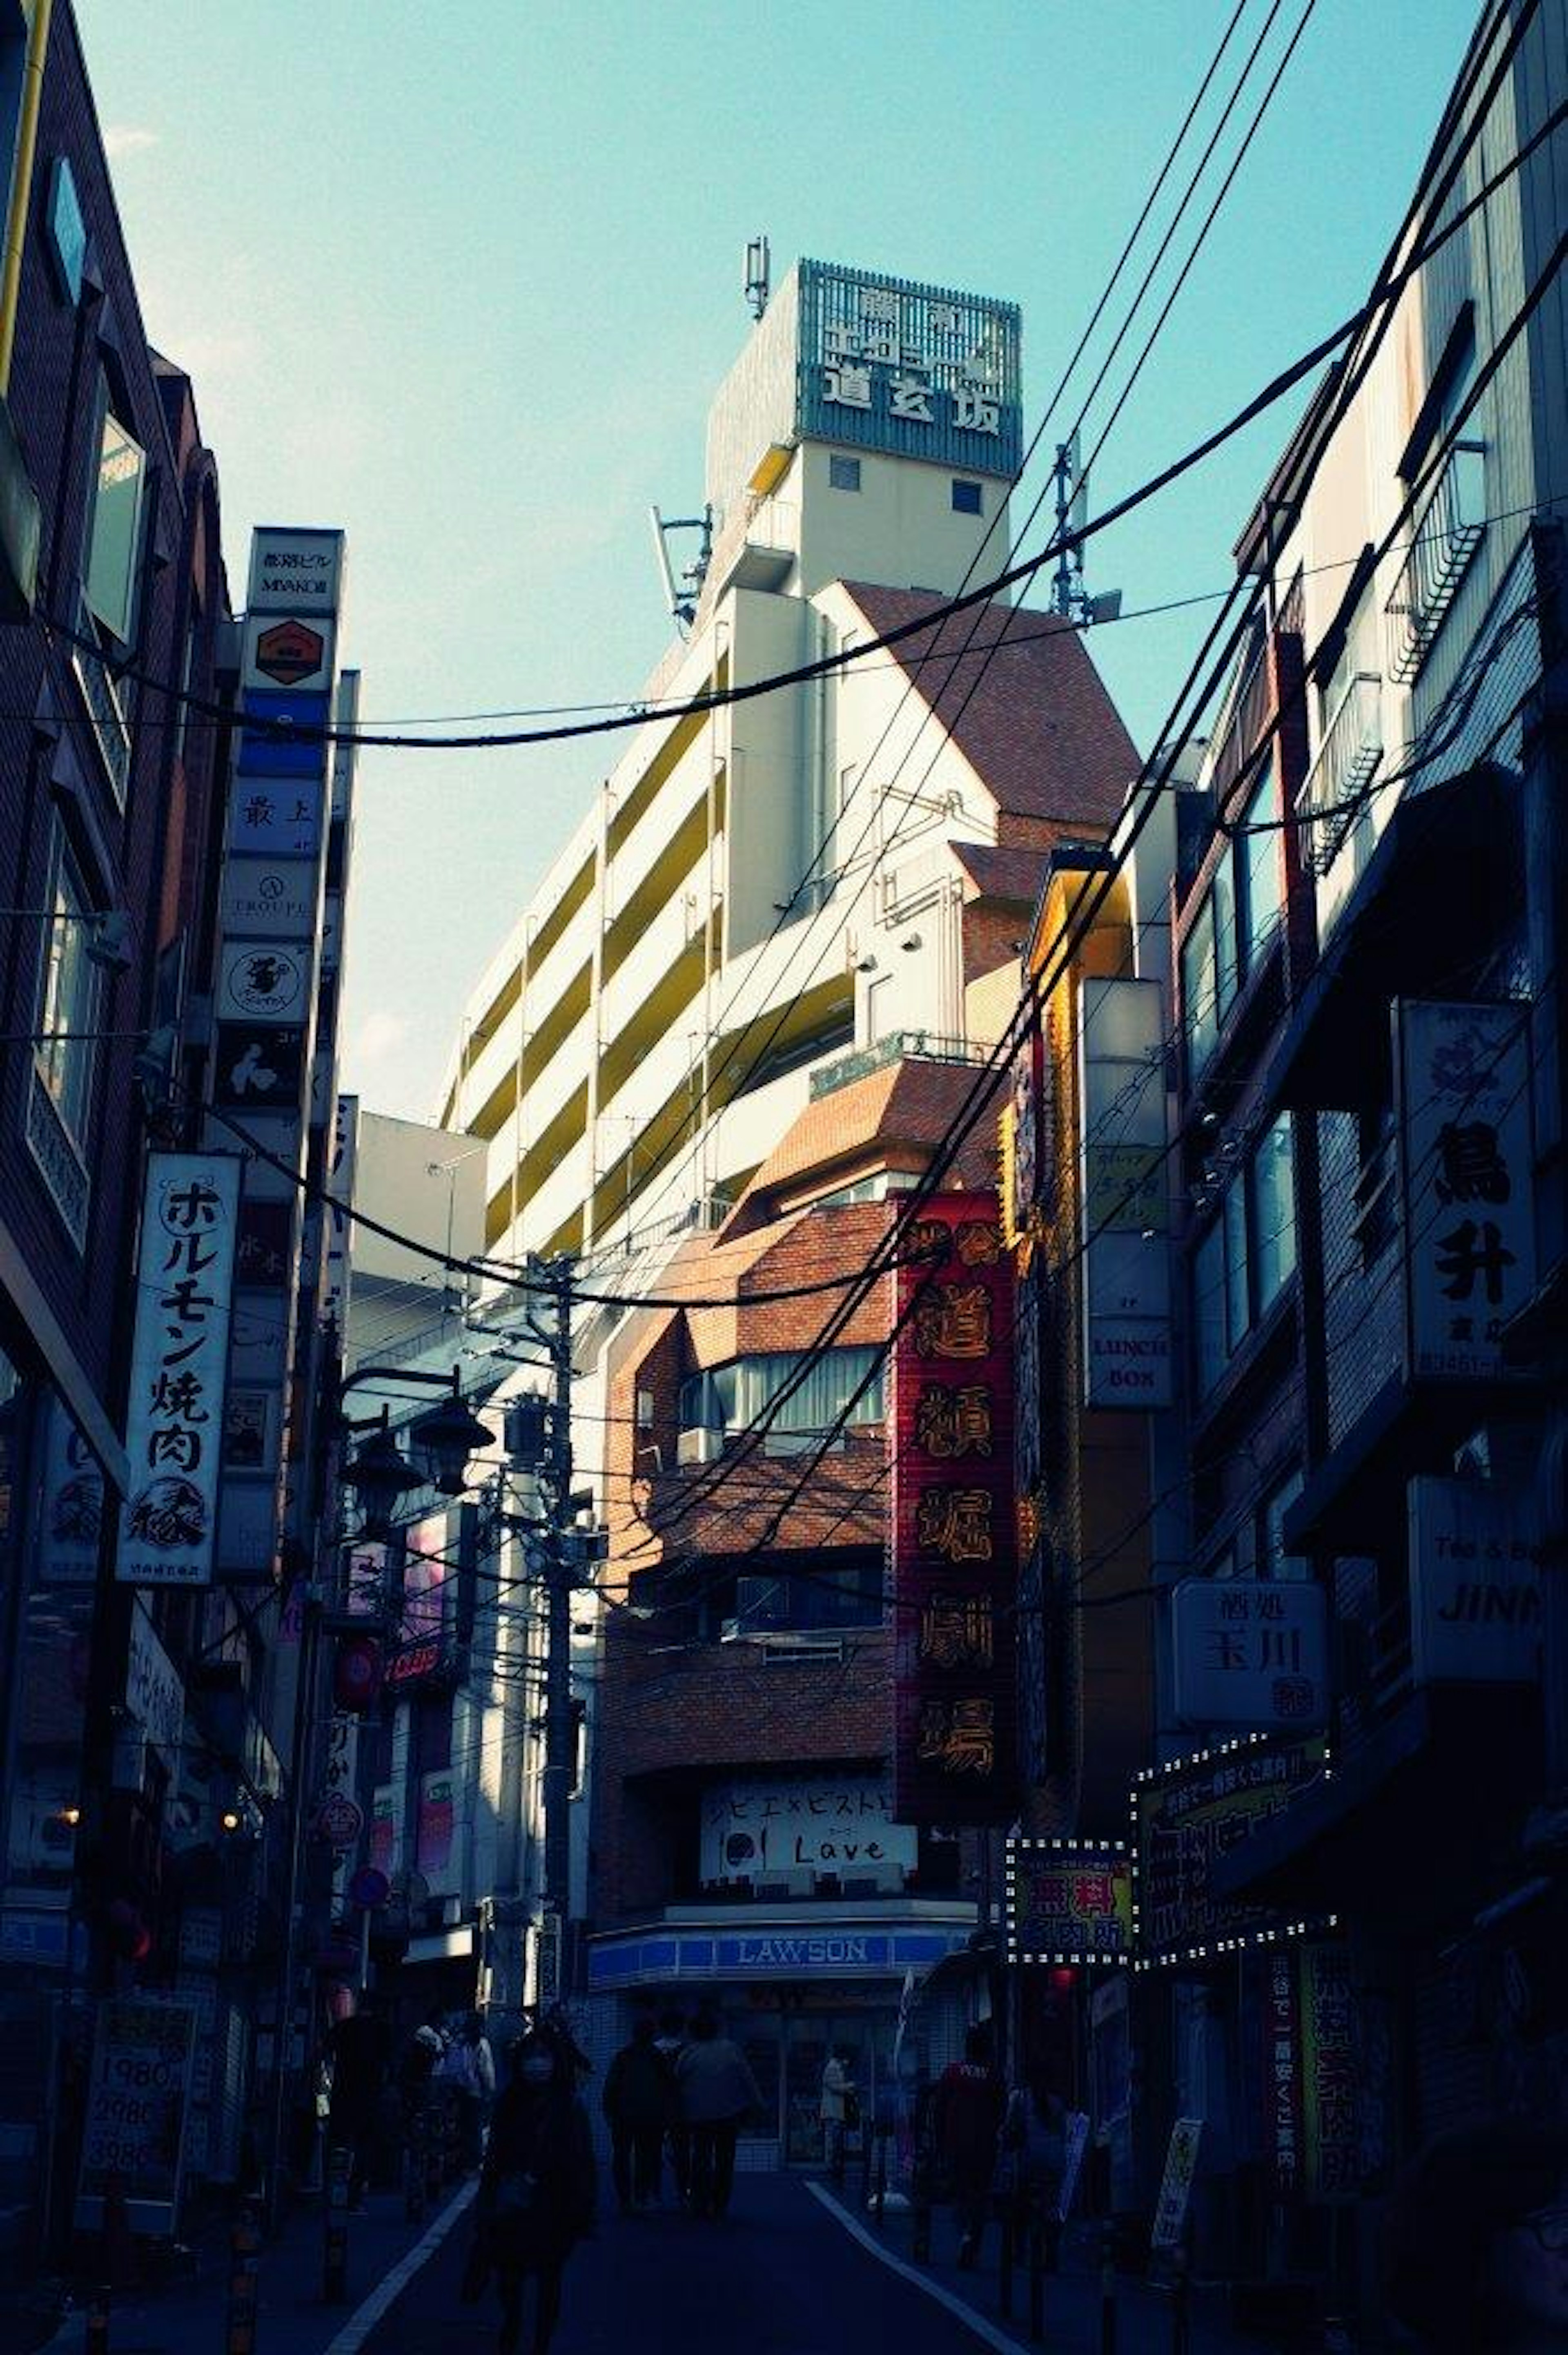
[1394,999,1535,1383]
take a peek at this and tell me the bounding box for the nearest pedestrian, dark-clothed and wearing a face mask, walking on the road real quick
[461,2028,593,2355]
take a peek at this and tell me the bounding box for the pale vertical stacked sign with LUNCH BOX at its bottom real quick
[1078,980,1175,1408]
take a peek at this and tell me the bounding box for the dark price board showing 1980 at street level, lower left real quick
[76,1997,196,2239]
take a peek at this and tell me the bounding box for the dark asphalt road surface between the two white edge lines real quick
[365,2176,1007,2355]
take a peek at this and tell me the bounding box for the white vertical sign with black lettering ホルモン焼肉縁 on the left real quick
[116,1154,240,1587]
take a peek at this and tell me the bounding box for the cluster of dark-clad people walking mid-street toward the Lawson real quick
[603,2011,763,2221]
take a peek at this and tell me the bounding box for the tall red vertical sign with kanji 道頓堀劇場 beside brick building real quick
[888,1194,1017,1825]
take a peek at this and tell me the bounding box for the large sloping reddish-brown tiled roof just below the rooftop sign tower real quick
[843,582,1137,831]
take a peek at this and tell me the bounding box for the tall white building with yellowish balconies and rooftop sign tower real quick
[443,261,1135,1258]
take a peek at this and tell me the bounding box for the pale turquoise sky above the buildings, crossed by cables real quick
[78,0,1474,1119]
